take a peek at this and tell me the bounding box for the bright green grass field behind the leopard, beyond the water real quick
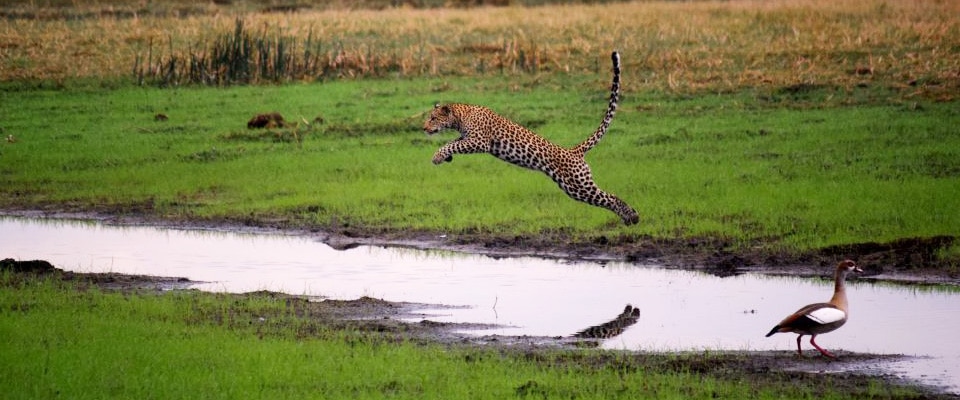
[0,75,960,255]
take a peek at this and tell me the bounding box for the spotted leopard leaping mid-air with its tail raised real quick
[423,51,640,225]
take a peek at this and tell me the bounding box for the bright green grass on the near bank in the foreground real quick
[0,273,919,399]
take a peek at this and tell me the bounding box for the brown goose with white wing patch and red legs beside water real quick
[767,260,863,358]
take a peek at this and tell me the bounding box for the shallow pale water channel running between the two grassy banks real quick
[0,216,960,393]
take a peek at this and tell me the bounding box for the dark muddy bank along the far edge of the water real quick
[0,210,960,285]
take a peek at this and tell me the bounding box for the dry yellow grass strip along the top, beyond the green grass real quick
[0,0,960,96]
